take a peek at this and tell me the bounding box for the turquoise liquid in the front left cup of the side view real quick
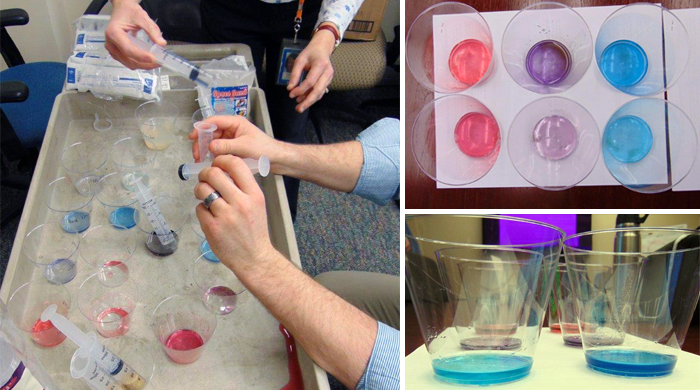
[433,353,532,386]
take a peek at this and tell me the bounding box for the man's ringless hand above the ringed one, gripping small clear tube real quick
[190,115,283,165]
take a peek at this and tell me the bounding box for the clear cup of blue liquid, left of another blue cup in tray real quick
[44,176,93,233]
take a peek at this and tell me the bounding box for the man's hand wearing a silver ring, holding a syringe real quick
[194,156,275,277]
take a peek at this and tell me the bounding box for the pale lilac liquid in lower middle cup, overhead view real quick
[532,115,578,161]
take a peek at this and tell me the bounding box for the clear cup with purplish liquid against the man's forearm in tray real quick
[192,254,246,315]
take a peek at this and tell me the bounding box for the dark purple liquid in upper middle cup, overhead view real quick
[525,39,571,85]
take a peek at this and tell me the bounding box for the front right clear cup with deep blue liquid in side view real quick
[564,228,700,377]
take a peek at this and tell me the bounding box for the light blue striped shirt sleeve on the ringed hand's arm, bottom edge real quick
[357,322,401,390]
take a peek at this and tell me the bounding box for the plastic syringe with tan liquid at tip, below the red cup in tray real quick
[41,305,147,390]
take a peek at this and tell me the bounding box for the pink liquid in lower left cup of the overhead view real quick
[455,112,501,157]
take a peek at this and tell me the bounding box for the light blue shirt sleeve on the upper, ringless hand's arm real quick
[352,118,401,205]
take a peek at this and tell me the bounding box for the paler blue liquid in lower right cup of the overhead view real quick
[603,115,654,163]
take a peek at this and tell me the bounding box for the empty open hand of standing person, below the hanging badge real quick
[287,25,335,113]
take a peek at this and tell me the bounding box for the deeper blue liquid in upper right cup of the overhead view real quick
[599,39,649,88]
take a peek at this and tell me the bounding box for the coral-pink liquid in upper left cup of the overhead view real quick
[449,39,491,87]
